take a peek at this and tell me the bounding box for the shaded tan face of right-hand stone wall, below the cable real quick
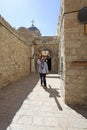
[65,13,87,104]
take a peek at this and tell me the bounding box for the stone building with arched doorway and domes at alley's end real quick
[17,24,58,73]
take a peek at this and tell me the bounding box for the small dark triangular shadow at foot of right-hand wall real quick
[69,105,87,119]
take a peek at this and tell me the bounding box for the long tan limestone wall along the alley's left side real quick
[0,17,30,88]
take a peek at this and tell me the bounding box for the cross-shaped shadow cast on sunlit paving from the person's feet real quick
[45,85,63,111]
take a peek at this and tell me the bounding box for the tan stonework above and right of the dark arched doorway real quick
[34,37,58,73]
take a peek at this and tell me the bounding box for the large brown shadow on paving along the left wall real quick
[0,74,39,130]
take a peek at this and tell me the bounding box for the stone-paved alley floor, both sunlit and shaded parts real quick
[0,74,87,130]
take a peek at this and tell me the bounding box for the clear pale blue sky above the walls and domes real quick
[0,0,60,36]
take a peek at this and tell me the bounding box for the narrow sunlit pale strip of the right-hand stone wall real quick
[57,0,65,100]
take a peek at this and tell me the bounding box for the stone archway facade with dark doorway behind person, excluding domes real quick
[32,36,58,73]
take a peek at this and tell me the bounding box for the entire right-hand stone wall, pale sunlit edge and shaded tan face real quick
[58,0,87,105]
